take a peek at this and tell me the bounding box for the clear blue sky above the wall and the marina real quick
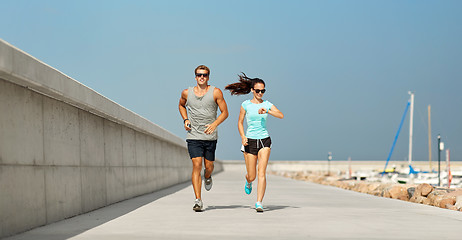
[0,0,462,161]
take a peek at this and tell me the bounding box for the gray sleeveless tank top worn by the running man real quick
[186,86,218,140]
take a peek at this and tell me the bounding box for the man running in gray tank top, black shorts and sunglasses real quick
[178,65,228,212]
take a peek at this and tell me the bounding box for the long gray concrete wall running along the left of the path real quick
[0,39,222,238]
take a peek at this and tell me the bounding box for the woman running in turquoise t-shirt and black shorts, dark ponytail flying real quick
[225,73,284,212]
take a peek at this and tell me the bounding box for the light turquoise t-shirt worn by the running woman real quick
[242,100,273,139]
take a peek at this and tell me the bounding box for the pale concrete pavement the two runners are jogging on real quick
[8,165,462,240]
